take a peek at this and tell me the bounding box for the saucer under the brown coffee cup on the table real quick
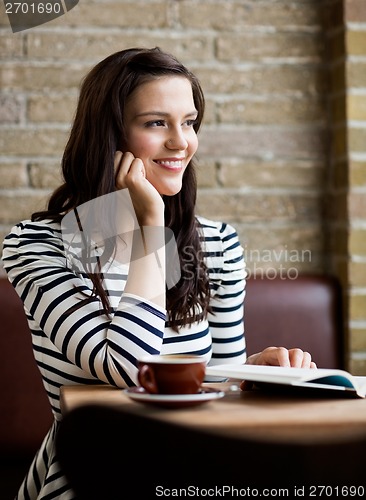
[123,387,225,408]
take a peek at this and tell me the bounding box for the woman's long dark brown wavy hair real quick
[32,47,209,331]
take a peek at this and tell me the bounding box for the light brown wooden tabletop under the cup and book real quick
[61,381,366,443]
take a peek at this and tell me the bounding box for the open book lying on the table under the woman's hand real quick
[206,365,366,398]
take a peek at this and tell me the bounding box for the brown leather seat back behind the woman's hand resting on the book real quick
[244,275,344,368]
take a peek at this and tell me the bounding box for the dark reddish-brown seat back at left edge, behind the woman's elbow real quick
[0,277,52,456]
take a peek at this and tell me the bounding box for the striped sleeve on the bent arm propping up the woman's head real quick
[3,222,166,387]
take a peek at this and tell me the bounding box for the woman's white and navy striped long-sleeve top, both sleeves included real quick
[2,213,246,500]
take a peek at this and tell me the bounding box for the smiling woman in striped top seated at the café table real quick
[3,48,314,499]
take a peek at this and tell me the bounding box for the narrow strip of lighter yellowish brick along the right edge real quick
[344,0,366,375]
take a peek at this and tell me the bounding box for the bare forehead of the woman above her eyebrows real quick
[126,76,195,112]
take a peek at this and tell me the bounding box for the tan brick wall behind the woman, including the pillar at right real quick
[0,0,366,372]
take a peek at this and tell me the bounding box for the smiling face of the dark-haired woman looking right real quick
[125,76,198,196]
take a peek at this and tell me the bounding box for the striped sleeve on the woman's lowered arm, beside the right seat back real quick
[208,224,246,365]
